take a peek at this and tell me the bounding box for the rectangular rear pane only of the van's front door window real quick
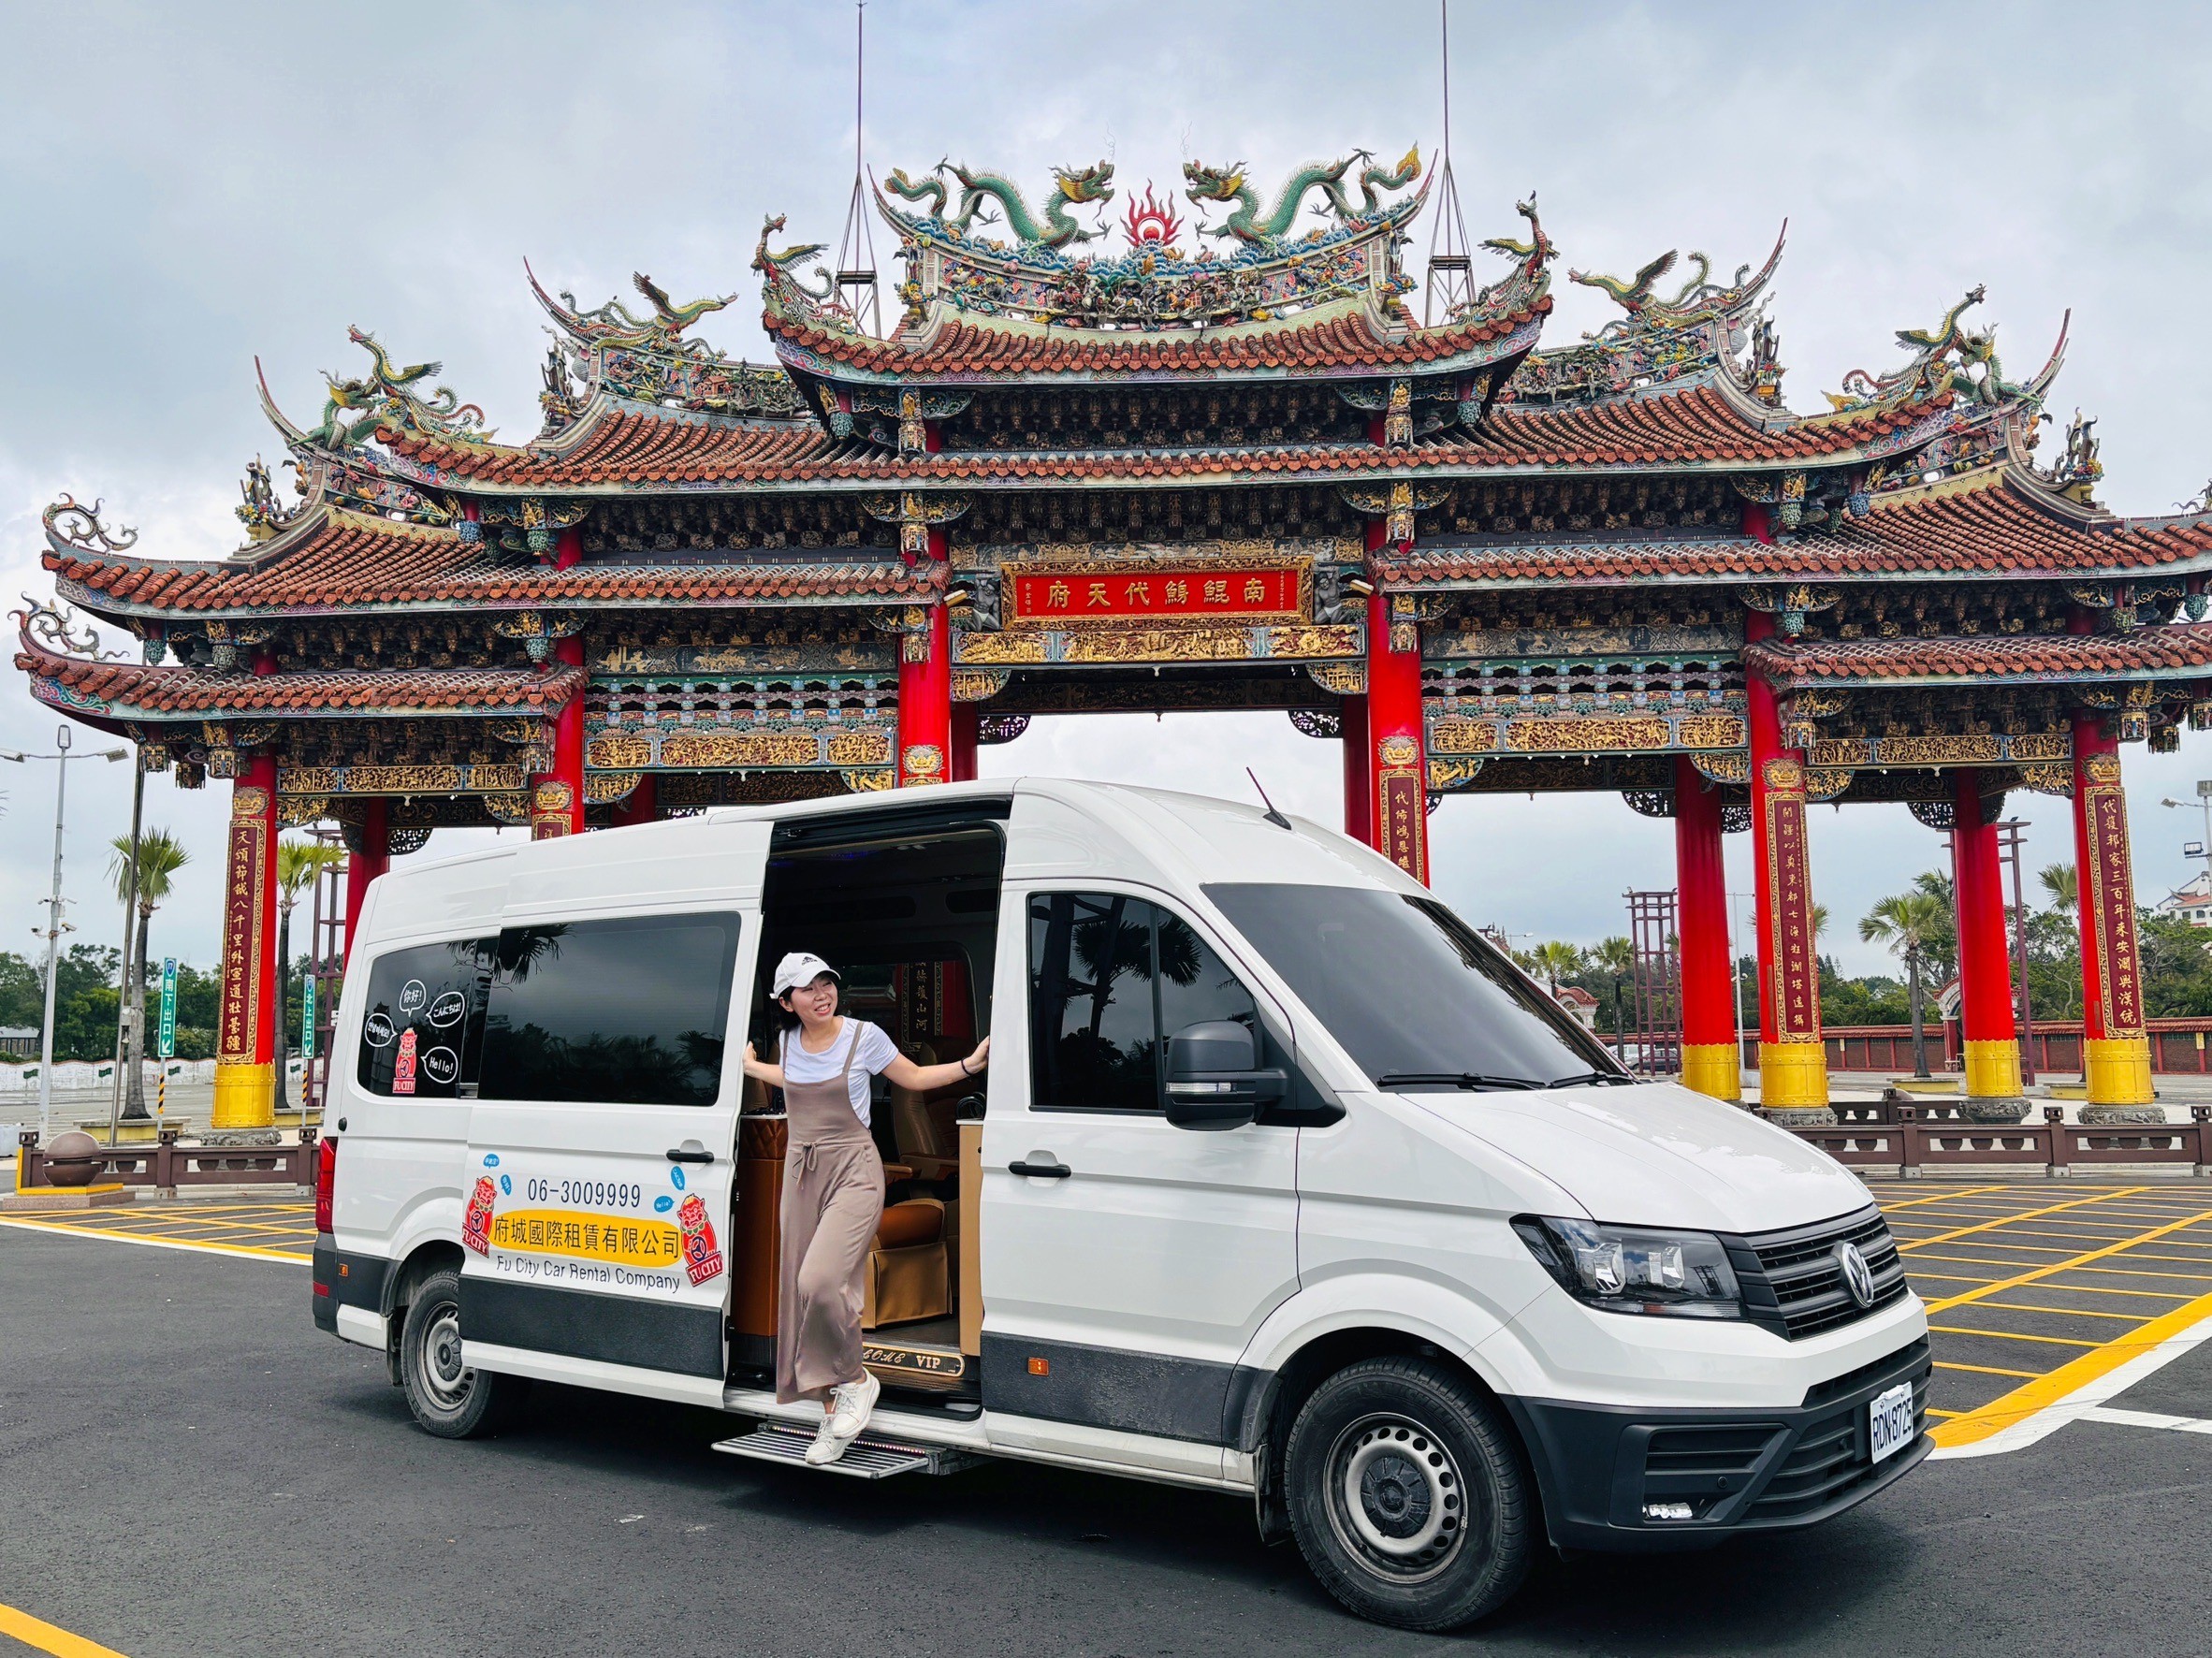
[1028,894,1159,1112]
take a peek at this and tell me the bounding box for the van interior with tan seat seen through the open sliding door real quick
[730,800,1007,1410]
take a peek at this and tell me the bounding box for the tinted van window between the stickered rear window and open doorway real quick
[482,915,739,1105]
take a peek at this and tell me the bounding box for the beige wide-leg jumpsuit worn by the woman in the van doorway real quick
[777,1019,882,1403]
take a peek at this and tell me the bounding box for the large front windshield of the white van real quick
[1205,882,1633,1090]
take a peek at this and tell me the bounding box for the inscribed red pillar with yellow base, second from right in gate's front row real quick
[1743,614,1834,1121]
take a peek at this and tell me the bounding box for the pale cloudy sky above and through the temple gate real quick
[0,0,2212,970]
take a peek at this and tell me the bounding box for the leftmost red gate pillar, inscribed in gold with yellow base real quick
[208,749,279,1127]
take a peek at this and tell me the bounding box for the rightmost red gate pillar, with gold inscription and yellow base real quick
[2073,709,2155,1121]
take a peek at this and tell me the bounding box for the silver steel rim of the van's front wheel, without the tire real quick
[1327,1415,1466,1585]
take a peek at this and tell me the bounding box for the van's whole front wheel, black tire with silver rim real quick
[1283,1358,1535,1632]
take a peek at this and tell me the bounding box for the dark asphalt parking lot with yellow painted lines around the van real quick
[0,1183,2212,1658]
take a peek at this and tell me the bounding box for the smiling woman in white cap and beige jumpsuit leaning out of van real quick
[746,953,991,1463]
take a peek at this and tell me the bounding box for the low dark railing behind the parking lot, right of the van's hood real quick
[1789,1105,2212,1181]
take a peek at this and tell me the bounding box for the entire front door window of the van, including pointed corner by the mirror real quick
[1028,894,1259,1112]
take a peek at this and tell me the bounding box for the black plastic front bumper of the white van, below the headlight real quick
[1505,1337,1931,1552]
